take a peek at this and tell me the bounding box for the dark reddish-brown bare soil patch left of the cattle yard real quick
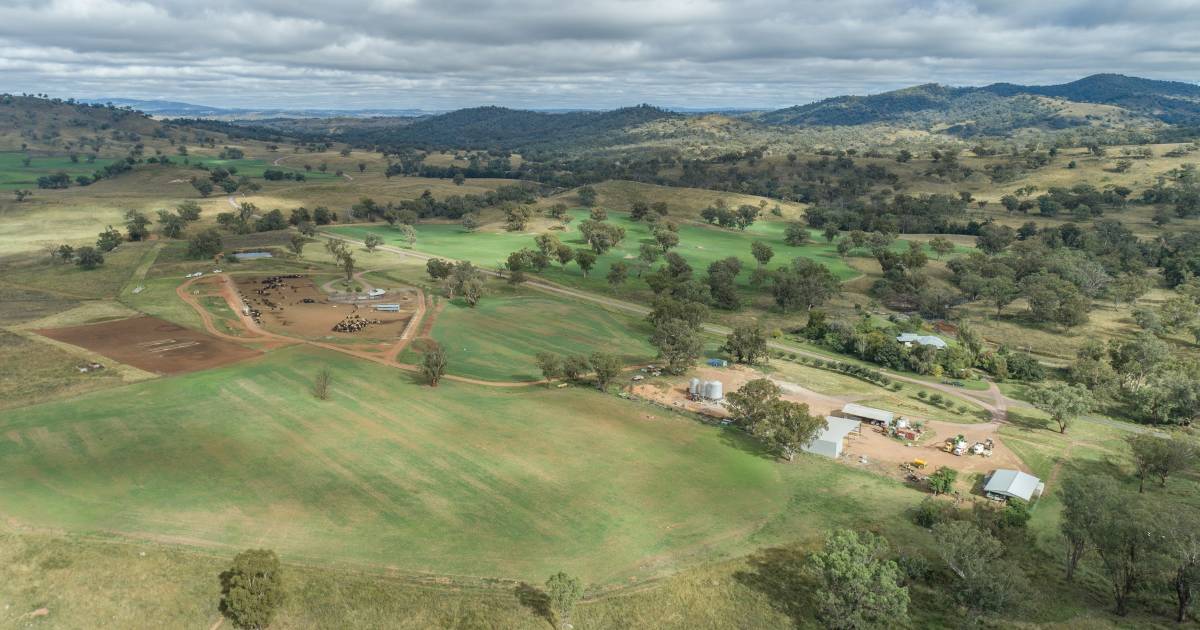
[35,317,259,374]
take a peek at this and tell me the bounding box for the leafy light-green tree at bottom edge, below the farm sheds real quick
[806,529,908,630]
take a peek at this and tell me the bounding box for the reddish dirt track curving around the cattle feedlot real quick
[175,274,546,388]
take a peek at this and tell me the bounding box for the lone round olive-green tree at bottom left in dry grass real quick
[221,550,283,629]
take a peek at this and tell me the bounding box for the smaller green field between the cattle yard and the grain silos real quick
[406,295,655,380]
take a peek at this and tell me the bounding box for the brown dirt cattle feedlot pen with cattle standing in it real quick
[236,276,420,341]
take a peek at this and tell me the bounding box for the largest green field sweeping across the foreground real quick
[0,348,918,583]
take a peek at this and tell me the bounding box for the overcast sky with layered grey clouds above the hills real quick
[0,0,1200,109]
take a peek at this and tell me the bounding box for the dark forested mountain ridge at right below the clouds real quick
[756,74,1200,126]
